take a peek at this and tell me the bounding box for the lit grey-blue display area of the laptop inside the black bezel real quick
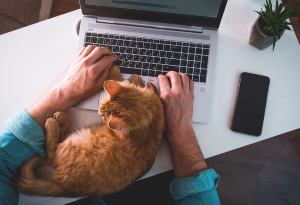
[85,0,222,18]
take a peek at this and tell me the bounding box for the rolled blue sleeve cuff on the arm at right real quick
[170,169,220,205]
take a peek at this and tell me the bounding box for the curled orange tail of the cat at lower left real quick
[15,156,63,196]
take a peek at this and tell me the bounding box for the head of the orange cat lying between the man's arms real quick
[99,80,161,133]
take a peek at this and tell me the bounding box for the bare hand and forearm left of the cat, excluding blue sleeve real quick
[26,45,118,128]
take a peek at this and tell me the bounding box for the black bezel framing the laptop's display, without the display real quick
[79,0,228,29]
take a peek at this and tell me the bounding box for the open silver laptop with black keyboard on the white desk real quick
[74,0,227,123]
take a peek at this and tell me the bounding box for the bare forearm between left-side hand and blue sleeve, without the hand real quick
[26,86,78,129]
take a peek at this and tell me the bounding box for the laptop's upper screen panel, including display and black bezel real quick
[80,0,228,28]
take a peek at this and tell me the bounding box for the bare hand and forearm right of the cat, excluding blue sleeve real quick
[148,71,207,177]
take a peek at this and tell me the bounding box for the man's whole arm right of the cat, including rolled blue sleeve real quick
[148,71,220,205]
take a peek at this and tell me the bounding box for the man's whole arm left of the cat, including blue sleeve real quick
[0,46,118,204]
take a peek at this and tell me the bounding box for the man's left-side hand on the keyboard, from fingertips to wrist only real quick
[59,45,118,103]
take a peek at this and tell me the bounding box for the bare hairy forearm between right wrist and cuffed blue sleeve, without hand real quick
[168,125,208,177]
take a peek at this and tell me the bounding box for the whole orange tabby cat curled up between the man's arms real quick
[15,66,165,197]
